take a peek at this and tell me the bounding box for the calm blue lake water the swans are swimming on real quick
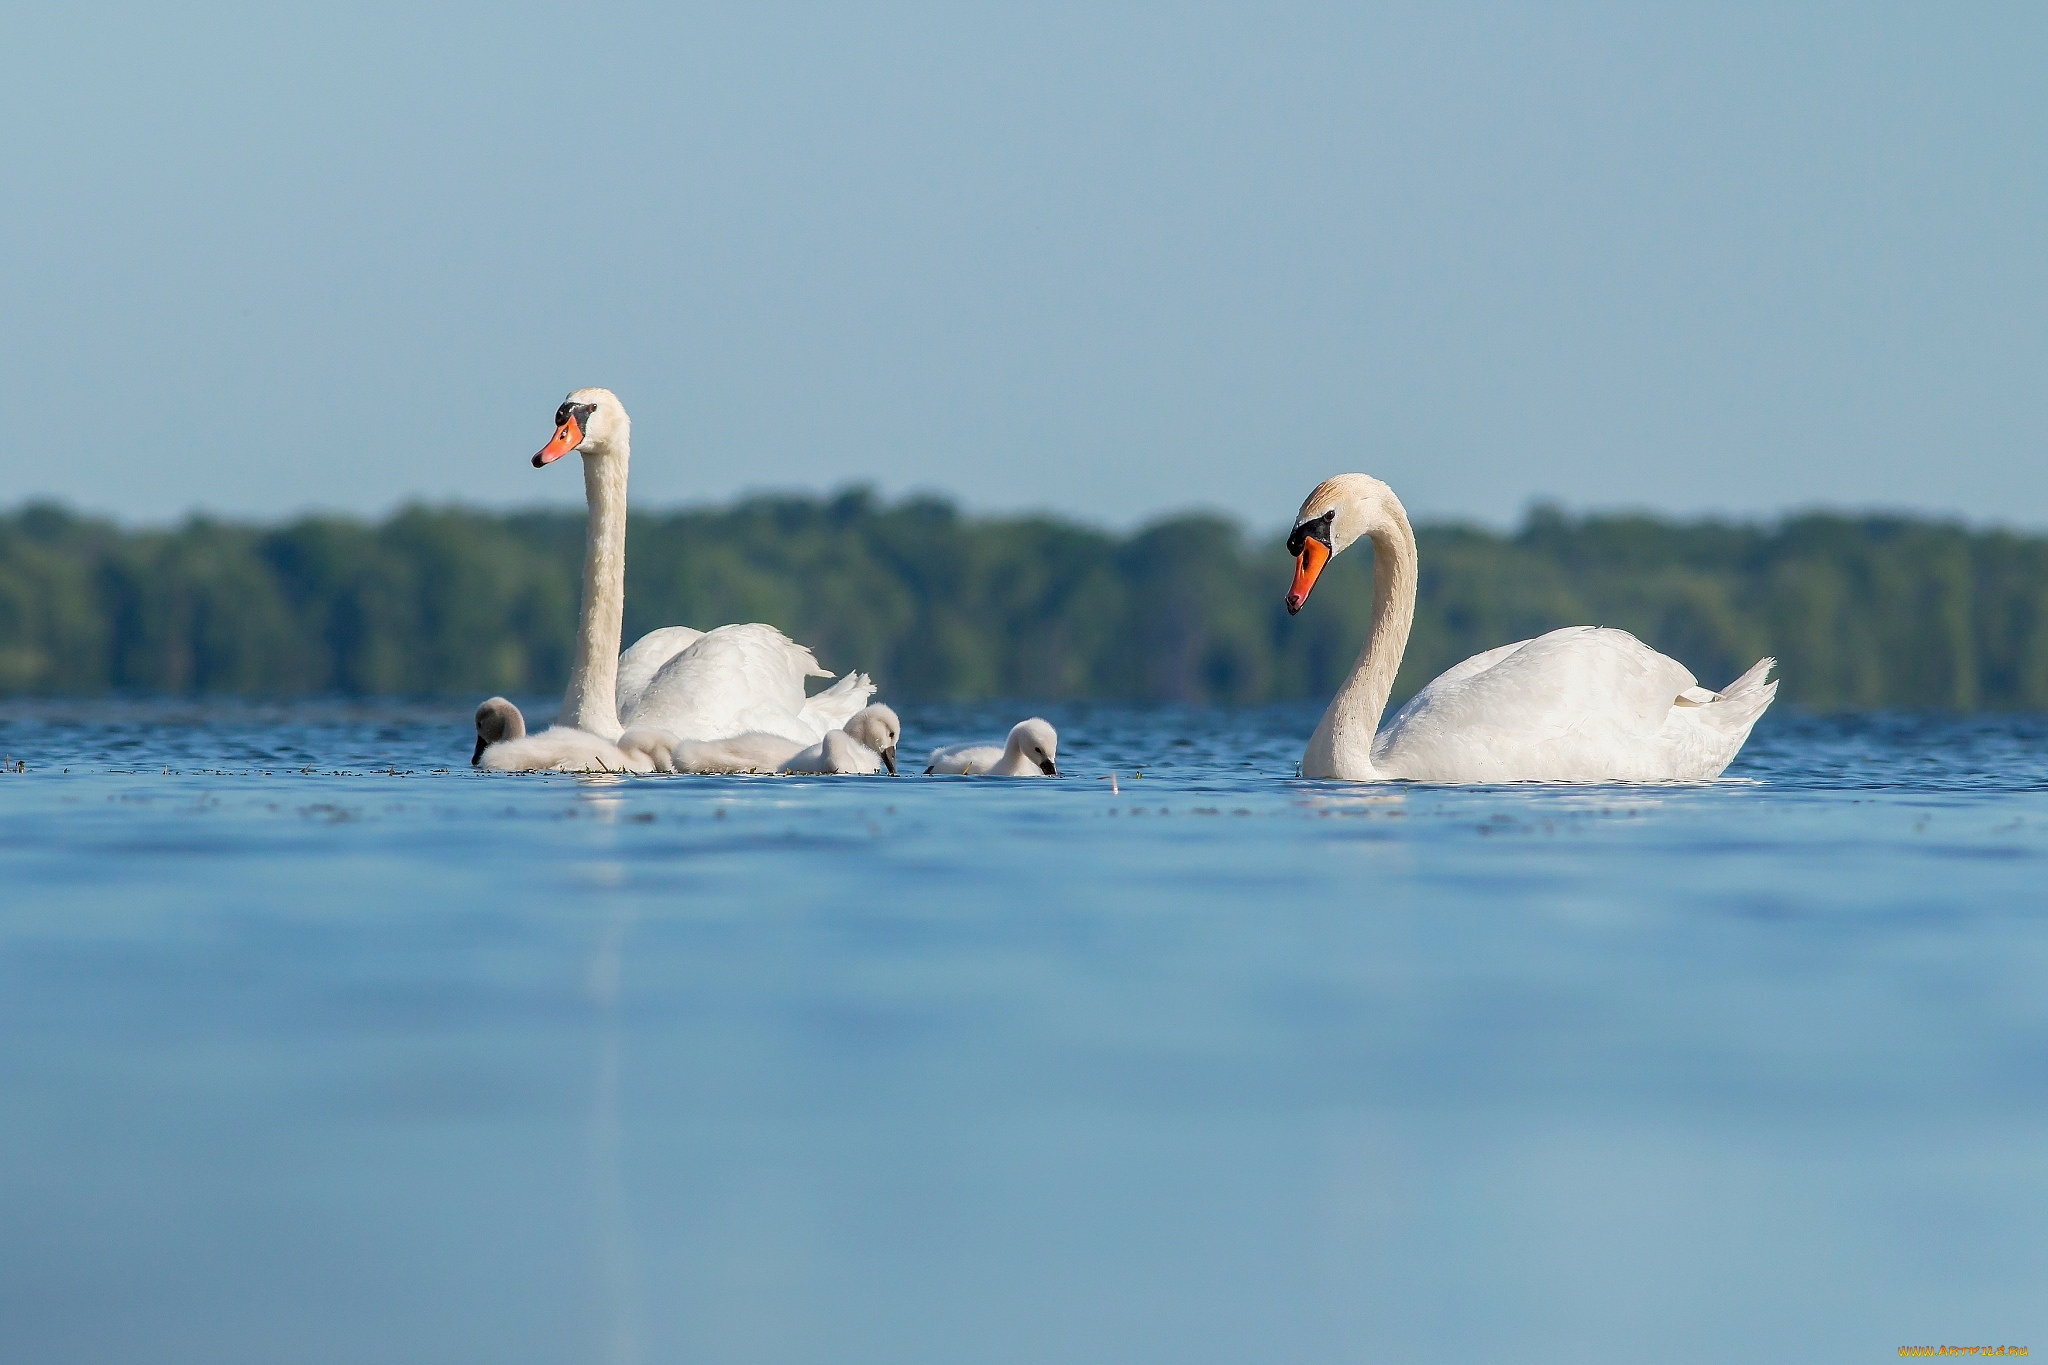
[0,702,2048,1365]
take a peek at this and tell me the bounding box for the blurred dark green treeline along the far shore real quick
[0,489,2048,710]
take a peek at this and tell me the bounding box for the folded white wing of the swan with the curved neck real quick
[1372,626,1698,782]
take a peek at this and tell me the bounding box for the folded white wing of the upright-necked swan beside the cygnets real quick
[621,622,831,745]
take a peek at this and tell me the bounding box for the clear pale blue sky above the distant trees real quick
[0,0,2048,526]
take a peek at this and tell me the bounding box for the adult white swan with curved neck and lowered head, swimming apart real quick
[1286,475,1778,782]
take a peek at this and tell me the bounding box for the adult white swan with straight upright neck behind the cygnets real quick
[532,389,874,745]
